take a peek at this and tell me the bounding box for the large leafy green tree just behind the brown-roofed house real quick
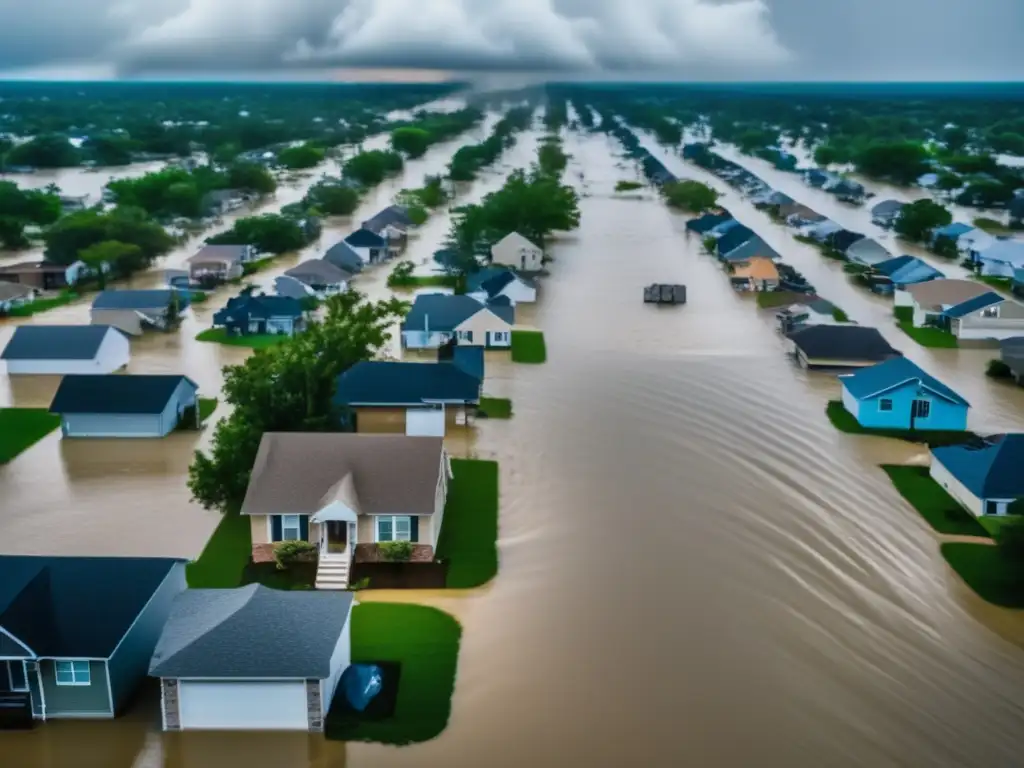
[188,291,408,512]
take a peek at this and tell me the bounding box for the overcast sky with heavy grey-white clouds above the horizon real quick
[0,0,1024,80]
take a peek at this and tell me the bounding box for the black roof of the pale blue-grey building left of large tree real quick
[50,374,199,414]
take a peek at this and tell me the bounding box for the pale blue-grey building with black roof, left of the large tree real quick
[50,374,199,437]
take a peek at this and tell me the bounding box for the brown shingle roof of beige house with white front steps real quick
[242,432,443,515]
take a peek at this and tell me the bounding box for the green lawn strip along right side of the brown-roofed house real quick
[437,459,498,589]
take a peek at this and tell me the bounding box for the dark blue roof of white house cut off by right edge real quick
[932,433,1024,499]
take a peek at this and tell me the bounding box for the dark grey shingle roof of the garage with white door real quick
[150,584,353,680]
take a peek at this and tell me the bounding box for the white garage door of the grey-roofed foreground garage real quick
[178,680,308,730]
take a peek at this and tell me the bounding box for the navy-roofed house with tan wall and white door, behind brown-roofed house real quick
[334,360,481,437]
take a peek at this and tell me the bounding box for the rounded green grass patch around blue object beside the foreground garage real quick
[324,602,462,744]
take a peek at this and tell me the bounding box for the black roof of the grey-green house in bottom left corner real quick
[0,555,180,658]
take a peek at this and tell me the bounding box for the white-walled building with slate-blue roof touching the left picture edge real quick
[0,326,131,376]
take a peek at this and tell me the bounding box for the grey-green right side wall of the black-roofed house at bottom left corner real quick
[106,563,185,712]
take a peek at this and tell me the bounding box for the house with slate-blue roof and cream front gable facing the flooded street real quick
[401,293,515,349]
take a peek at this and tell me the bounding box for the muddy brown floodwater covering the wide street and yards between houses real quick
[6,123,1024,768]
